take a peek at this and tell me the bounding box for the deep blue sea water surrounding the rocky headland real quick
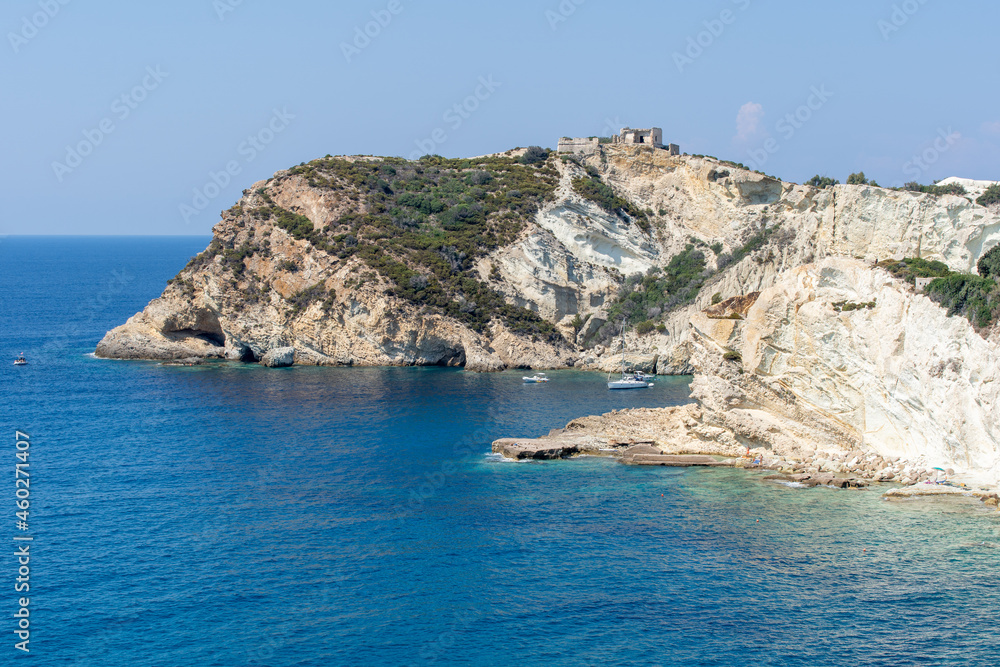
[0,237,1000,666]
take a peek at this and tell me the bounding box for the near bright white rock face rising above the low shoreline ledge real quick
[692,258,1000,484]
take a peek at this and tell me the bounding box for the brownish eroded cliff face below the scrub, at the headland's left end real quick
[97,223,574,371]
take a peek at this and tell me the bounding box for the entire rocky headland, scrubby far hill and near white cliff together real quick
[97,144,1000,488]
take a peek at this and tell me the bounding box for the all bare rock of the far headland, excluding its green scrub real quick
[97,146,1000,373]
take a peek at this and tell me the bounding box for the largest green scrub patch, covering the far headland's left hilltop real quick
[200,149,559,340]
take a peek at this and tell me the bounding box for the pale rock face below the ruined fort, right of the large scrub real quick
[479,146,1000,373]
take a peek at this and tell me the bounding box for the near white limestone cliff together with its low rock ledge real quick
[494,257,1000,486]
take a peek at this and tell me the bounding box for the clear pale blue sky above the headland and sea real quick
[0,0,1000,235]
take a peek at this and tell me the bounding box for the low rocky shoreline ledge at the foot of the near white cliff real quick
[492,404,1000,511]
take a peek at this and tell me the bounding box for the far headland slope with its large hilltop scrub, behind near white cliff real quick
[97,146,1000,373]
